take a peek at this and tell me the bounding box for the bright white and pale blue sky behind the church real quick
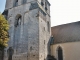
[0,0,80,26]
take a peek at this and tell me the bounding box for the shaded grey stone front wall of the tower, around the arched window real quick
[4,3,39,60]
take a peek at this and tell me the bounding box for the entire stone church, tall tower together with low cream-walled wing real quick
[3,0,80,60]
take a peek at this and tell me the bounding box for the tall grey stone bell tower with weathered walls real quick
[4,0,51,60]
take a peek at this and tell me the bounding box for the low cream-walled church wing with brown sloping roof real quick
[50,21,80,60]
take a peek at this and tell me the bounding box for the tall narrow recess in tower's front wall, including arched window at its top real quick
[13,14,22,54]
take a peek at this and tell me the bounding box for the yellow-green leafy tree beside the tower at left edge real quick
[0,14,9,48]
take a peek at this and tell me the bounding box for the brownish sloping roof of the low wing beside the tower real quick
[51,21,80,44]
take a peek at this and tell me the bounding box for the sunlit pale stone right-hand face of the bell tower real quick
[39,7,51,60]
